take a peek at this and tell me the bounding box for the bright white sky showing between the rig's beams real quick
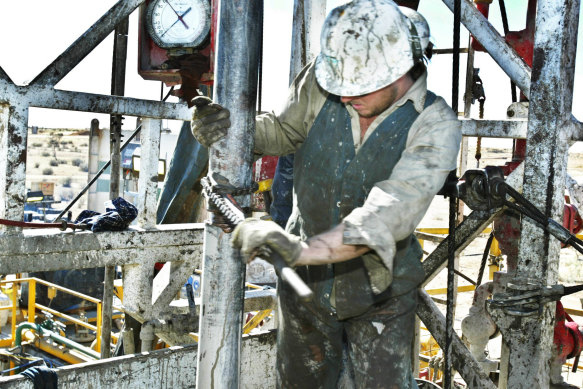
[0,0,583,138]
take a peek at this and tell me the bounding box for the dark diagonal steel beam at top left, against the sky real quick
[31,0,145,86]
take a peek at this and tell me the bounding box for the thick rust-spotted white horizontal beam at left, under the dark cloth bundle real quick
[0,223,203,274]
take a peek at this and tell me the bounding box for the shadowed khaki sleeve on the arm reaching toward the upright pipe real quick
[255,62,327,156]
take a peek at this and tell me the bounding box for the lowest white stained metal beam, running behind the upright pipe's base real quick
[0,332,276,389]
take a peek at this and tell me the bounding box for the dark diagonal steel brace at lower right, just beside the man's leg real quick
[417,289,496,389]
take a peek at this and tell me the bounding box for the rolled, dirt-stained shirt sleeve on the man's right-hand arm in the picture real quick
[343,97,461,269]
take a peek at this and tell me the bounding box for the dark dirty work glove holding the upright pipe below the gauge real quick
[190,96,231,147]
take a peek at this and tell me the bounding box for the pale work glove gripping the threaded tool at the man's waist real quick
[231,218,302,266]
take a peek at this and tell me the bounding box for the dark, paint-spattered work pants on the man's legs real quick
[277,283,417,389]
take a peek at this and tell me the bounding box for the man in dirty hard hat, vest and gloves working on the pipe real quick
[192,0,461,388]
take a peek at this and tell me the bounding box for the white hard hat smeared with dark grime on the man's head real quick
[316,0,423,96]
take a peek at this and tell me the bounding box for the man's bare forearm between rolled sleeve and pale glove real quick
[295,224,370,266]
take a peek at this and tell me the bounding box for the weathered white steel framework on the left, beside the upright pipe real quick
[0,0,202,348]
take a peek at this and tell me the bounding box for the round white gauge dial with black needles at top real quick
[146,0,211,49]
